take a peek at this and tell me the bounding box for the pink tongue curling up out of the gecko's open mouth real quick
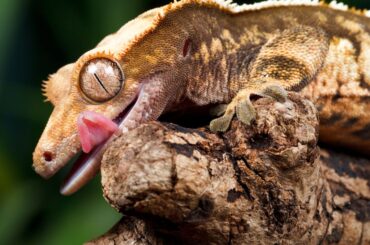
[77,111,118,153]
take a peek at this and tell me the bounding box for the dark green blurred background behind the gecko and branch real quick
[0,0,370,244]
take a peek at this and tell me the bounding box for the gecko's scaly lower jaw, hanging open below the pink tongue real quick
[56,73,171,195]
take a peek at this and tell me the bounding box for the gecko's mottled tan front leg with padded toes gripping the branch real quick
[210,26,329,132]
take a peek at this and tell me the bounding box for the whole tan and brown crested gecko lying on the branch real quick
[33,0,370,194]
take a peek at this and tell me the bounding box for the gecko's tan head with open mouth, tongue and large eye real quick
[33,4,197,194]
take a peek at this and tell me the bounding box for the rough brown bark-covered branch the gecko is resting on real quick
[87,93,370,244]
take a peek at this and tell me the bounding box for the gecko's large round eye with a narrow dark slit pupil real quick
[79,58,124,103]
